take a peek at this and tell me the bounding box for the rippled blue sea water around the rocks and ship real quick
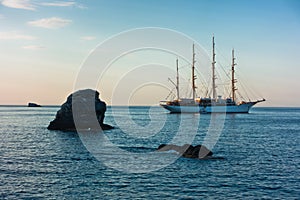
[0,106,300,199]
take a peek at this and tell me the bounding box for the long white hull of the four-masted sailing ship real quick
[161,102,256,113]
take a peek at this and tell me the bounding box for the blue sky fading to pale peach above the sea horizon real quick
[0,0,300,107]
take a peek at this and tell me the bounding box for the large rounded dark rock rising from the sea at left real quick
[48,89,113,131]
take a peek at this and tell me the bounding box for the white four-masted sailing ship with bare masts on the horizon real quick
[160,37,265,113]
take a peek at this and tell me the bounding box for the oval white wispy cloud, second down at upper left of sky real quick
[28,17,72,29]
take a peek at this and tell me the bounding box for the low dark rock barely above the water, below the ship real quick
[157,144,213,159]
